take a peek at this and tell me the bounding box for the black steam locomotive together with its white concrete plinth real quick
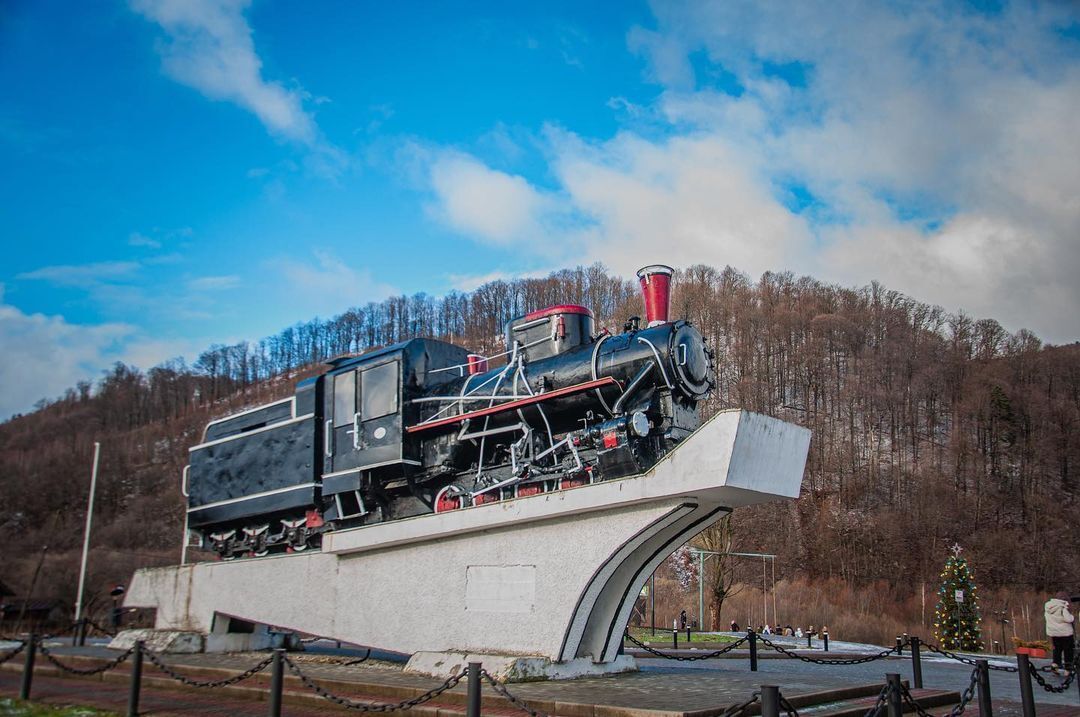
[125,266,810,677]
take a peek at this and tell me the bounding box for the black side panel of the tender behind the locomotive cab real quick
[188,416,319,527]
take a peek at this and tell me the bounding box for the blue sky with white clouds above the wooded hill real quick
[0,0,1080,418]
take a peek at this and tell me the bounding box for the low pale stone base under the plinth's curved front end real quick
[405,652,637,682]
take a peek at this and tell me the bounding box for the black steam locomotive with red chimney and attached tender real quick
[184,266,714,558]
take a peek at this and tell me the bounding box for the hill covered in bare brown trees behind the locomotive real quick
[0,266,1080,613]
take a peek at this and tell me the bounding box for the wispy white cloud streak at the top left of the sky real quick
[132,0,319,145]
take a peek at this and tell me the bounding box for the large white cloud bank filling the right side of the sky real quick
[416,1,1080,341]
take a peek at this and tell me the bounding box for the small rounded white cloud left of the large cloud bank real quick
[430,151,552,245]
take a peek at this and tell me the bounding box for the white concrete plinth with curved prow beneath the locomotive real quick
[124,410,810,663]
